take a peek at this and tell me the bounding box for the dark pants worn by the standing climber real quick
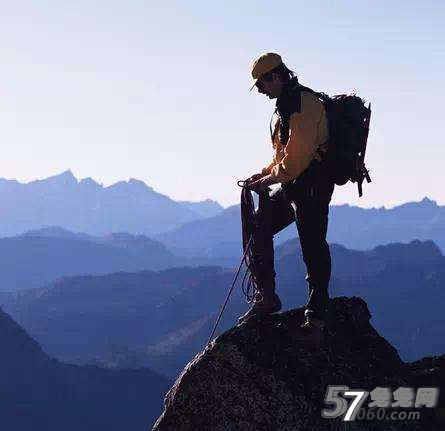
[253,161,334,319]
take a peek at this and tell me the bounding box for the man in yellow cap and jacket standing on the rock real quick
[240,53,334,341]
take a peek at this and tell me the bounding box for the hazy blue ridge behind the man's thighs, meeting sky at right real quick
[156,198,445,264]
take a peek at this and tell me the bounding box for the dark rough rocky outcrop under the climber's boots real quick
[153,297,445,431]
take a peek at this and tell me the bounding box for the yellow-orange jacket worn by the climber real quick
[261,91,328,183]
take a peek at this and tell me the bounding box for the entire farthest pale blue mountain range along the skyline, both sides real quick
[0,171,445,265]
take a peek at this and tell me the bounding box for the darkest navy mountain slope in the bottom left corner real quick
[0,310,171,431]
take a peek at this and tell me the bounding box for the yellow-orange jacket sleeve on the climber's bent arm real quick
[270,92,324,183]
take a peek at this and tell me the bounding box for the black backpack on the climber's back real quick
[274,84,371,196]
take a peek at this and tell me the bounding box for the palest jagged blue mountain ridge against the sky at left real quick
[0,171,217,236]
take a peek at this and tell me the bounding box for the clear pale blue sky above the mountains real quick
[0,0,445,207]
